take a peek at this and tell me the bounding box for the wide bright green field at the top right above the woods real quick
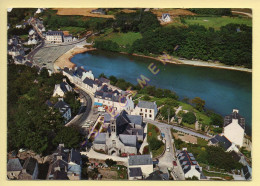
[185,16,252,30]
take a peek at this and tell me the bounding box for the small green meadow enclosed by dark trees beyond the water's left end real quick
[100,30,142,46]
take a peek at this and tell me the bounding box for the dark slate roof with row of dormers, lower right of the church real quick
[178,150,201,174]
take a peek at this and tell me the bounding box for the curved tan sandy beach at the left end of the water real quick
[54,46,96,70]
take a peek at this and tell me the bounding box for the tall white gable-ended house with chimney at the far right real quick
[224,109,245,147]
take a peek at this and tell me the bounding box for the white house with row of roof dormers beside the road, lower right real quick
[177,148,204,180]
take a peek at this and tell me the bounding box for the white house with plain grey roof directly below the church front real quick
[127,154,153,180]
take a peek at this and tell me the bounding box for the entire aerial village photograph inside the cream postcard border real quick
[6,8,252,181]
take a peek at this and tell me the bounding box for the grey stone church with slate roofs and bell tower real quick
[93,110,145,156]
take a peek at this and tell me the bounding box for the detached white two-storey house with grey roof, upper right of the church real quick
[131,100,158,120]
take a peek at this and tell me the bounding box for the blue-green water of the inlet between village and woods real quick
[71,51,252,135]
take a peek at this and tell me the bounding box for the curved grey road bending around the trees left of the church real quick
[66,89,92,126]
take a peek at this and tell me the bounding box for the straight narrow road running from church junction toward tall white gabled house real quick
[144,119,211,140]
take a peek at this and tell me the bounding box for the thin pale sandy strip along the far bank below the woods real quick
[126,52,252,73]
